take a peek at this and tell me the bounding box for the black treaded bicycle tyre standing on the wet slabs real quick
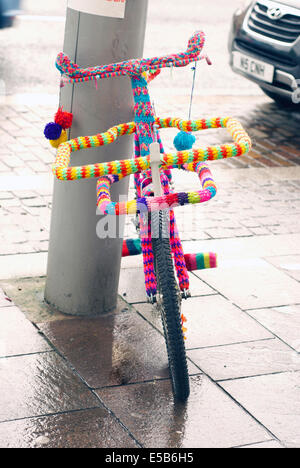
[151,211,190,401]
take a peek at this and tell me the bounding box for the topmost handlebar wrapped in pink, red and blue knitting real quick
[56,31,210,83]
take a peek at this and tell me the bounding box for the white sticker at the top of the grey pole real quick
[68,0,126,18]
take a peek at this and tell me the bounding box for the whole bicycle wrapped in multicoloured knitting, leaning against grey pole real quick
[45,32,251,401]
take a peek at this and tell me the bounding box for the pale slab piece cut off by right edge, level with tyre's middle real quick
[248,305,300,353]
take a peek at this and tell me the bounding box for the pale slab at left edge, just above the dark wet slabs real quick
[0,307,51,358]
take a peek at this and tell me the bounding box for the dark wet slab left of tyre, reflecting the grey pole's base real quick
[39,307,200,388]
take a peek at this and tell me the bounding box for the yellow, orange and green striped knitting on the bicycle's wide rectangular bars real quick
[52,117,251,186]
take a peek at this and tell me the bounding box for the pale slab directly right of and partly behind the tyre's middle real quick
[135,295,273,349]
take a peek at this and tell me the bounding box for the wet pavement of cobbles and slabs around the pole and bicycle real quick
[0,96,300,448]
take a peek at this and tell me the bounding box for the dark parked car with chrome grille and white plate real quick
[229,0,300,104]
